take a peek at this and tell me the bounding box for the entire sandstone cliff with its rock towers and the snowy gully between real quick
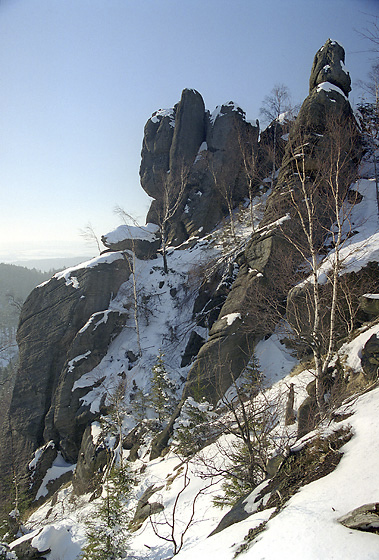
[1,40,376,524]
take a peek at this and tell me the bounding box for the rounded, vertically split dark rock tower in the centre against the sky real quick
[140,89,259,244]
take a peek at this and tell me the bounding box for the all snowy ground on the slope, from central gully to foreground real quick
[6,180,379,560]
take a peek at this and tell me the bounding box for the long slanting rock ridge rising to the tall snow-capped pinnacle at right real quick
[185,40,358,401]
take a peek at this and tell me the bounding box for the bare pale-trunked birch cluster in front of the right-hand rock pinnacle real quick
[281,111,357,416]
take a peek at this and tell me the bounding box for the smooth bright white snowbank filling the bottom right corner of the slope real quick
[235,389,379,560]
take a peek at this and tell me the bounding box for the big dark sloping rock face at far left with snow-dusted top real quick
[1,253,130,498]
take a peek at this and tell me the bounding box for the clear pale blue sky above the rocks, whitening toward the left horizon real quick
[0,0,379,262]
